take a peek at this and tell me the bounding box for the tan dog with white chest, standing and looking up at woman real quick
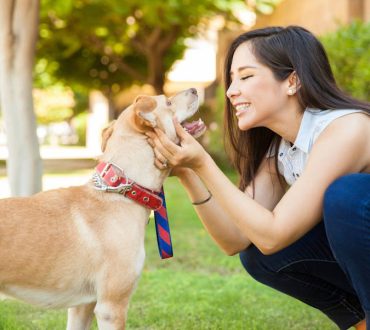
[0,89,205,330]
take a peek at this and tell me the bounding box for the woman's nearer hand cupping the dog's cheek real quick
[146,120,207,175]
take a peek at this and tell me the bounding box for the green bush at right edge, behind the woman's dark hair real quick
[321,21,370,100]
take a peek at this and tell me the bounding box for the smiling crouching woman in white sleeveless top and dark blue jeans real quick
[148,26,370,329]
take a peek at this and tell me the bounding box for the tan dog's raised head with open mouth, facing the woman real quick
[102,88,206,151]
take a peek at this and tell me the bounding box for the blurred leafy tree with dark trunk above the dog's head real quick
[38,0,246,96]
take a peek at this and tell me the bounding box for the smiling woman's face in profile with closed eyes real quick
[226,42,289,130]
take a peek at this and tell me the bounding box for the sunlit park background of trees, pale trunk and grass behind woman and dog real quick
[0,0,370,329]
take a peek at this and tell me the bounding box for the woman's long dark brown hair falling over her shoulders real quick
[224,26,370,191]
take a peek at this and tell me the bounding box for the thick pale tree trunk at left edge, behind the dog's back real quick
[0,0,42,196]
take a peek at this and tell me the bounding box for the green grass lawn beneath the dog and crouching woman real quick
[0,174,336,330]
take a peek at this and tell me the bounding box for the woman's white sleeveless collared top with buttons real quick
[274,108,366,185]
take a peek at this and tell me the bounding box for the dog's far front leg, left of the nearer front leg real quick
[67,302,96,330]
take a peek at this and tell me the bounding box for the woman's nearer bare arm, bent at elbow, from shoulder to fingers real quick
[147,114,370,254]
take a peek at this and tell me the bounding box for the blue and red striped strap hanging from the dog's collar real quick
[154,187,173,259]
